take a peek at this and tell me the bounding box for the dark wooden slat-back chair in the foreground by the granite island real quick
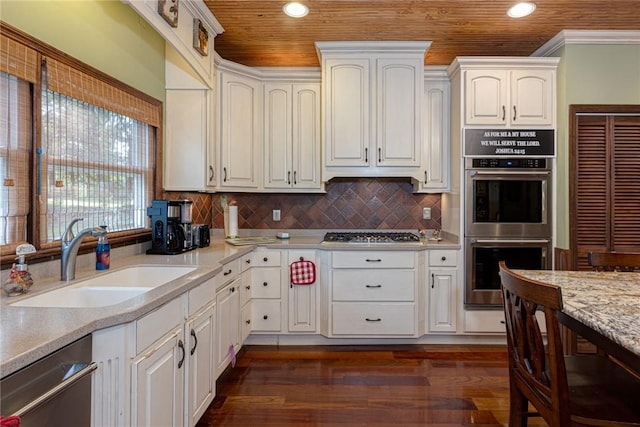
[500,261,640,427]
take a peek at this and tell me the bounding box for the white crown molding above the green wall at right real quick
[531,30,640,56]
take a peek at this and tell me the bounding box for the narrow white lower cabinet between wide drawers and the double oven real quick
[427,250,458,332]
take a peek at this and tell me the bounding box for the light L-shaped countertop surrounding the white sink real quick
[0,234,460,378]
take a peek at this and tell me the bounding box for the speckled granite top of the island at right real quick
[514,270,640,357]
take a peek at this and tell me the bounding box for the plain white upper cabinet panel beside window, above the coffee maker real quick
[164,89,216,191]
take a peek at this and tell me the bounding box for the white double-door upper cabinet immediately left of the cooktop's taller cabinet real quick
[263,82,321,191]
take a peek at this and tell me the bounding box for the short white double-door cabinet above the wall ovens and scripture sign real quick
[452,58,558,128]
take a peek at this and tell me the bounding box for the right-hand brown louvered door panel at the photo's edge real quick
[609,117,640,252]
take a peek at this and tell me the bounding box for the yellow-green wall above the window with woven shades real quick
[0,0,165,102]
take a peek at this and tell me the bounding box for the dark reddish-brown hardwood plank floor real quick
[197,345,546,427]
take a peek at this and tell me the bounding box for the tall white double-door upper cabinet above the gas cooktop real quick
[316,42,430,180]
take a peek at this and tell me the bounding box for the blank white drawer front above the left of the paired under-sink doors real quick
[135,297,184,353]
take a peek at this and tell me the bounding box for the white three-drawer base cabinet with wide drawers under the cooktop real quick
[329,251,418,337]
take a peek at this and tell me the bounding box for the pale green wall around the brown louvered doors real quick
[550,44,640,249]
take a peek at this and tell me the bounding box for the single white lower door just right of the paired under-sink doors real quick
[215,278,241,376]
